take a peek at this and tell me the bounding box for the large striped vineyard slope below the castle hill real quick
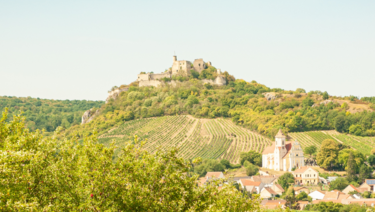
[99,116,271,163]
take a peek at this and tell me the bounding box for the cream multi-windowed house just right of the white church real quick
[292,166,319,185]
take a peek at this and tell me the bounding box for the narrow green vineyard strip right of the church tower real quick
[289,130,375,154]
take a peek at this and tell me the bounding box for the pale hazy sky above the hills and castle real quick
[0,0,375,100]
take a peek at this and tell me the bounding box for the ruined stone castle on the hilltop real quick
[137,55,227,87]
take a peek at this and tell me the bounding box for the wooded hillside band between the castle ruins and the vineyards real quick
[66,79,375,142]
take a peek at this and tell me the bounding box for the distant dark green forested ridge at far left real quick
[0,96,104,132]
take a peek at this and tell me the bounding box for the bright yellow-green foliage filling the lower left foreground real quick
[0,112,259,211]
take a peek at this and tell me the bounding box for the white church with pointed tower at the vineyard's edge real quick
[262,129,305,171]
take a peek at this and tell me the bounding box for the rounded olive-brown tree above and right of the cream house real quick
[316,139,339,169]
